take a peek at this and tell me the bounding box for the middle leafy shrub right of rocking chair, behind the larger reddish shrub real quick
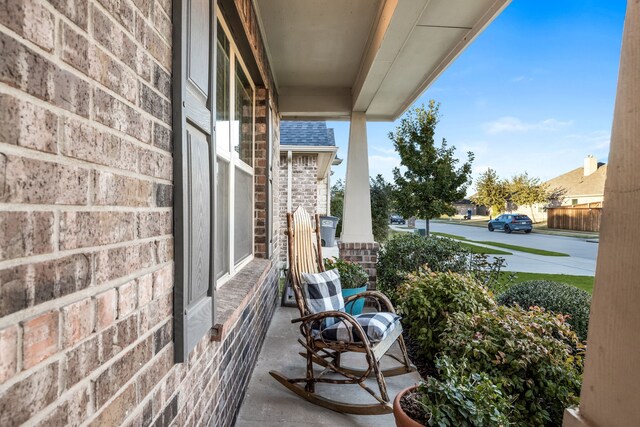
[398,270,495,358]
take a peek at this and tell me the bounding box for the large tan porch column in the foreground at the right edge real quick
[564,0,640,427]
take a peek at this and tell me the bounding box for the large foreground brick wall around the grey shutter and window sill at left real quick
[0,0,277,425]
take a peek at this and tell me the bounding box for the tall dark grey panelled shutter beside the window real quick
[173,0,216,362]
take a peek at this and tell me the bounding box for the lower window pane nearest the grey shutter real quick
[215,159,229,280]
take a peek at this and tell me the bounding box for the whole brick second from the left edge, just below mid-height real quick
[60,212,136,249]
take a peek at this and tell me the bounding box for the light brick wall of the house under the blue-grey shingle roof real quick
[279,152,318,263]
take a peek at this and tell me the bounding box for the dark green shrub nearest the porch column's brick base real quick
[376,233,468,303]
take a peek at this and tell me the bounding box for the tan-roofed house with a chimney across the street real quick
[515,155,607,221]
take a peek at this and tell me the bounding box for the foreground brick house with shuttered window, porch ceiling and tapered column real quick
[0,0,509,426]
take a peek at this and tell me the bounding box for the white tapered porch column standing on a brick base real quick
[340,111,373,243]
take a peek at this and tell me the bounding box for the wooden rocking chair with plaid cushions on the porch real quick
[269,207,416,415]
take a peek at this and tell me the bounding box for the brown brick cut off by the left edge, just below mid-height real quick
[0,211,53,261]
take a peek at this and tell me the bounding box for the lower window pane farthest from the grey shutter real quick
[233,168,253,264]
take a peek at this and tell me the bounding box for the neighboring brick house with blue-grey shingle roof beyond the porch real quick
[279,121,342,261]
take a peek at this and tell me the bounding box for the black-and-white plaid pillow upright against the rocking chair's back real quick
[302,269,344,326]
